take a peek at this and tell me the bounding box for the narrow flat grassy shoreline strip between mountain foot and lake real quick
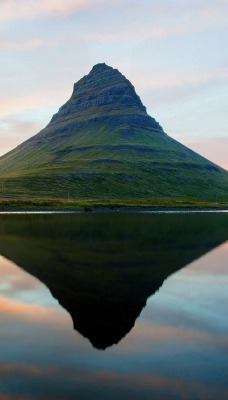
[0,196,228,213]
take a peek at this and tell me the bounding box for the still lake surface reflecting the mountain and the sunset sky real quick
[0,213,228,400]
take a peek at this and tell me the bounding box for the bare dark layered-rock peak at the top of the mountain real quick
[50,63,163,132]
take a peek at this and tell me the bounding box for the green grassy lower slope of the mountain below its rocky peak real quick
[0,126,228,200]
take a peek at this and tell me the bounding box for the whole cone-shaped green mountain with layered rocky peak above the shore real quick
[0,63,228,200]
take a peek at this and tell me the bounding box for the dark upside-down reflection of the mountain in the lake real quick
[0,213,228,349]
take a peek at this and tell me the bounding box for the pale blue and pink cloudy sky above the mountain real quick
[0,0,228,169]
